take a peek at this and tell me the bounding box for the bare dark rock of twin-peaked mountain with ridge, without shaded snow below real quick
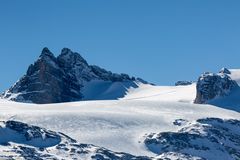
[2,48,138,104]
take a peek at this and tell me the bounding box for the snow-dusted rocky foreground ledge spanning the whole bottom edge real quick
[0,118,240,160]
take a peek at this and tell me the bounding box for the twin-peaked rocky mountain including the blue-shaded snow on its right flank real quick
[3,48,146,104]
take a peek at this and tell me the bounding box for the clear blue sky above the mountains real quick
[0,0,240,91]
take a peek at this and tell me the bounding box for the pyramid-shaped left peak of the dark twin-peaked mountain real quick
[4,48,82,103]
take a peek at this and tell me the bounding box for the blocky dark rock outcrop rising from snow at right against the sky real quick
[194,72,239,104]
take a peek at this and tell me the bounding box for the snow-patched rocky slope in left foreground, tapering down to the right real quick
[0,121,150,160]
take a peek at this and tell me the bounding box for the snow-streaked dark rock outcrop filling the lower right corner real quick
[144,118,240,160]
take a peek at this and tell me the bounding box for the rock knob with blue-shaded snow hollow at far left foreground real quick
[0,120,61,147]
